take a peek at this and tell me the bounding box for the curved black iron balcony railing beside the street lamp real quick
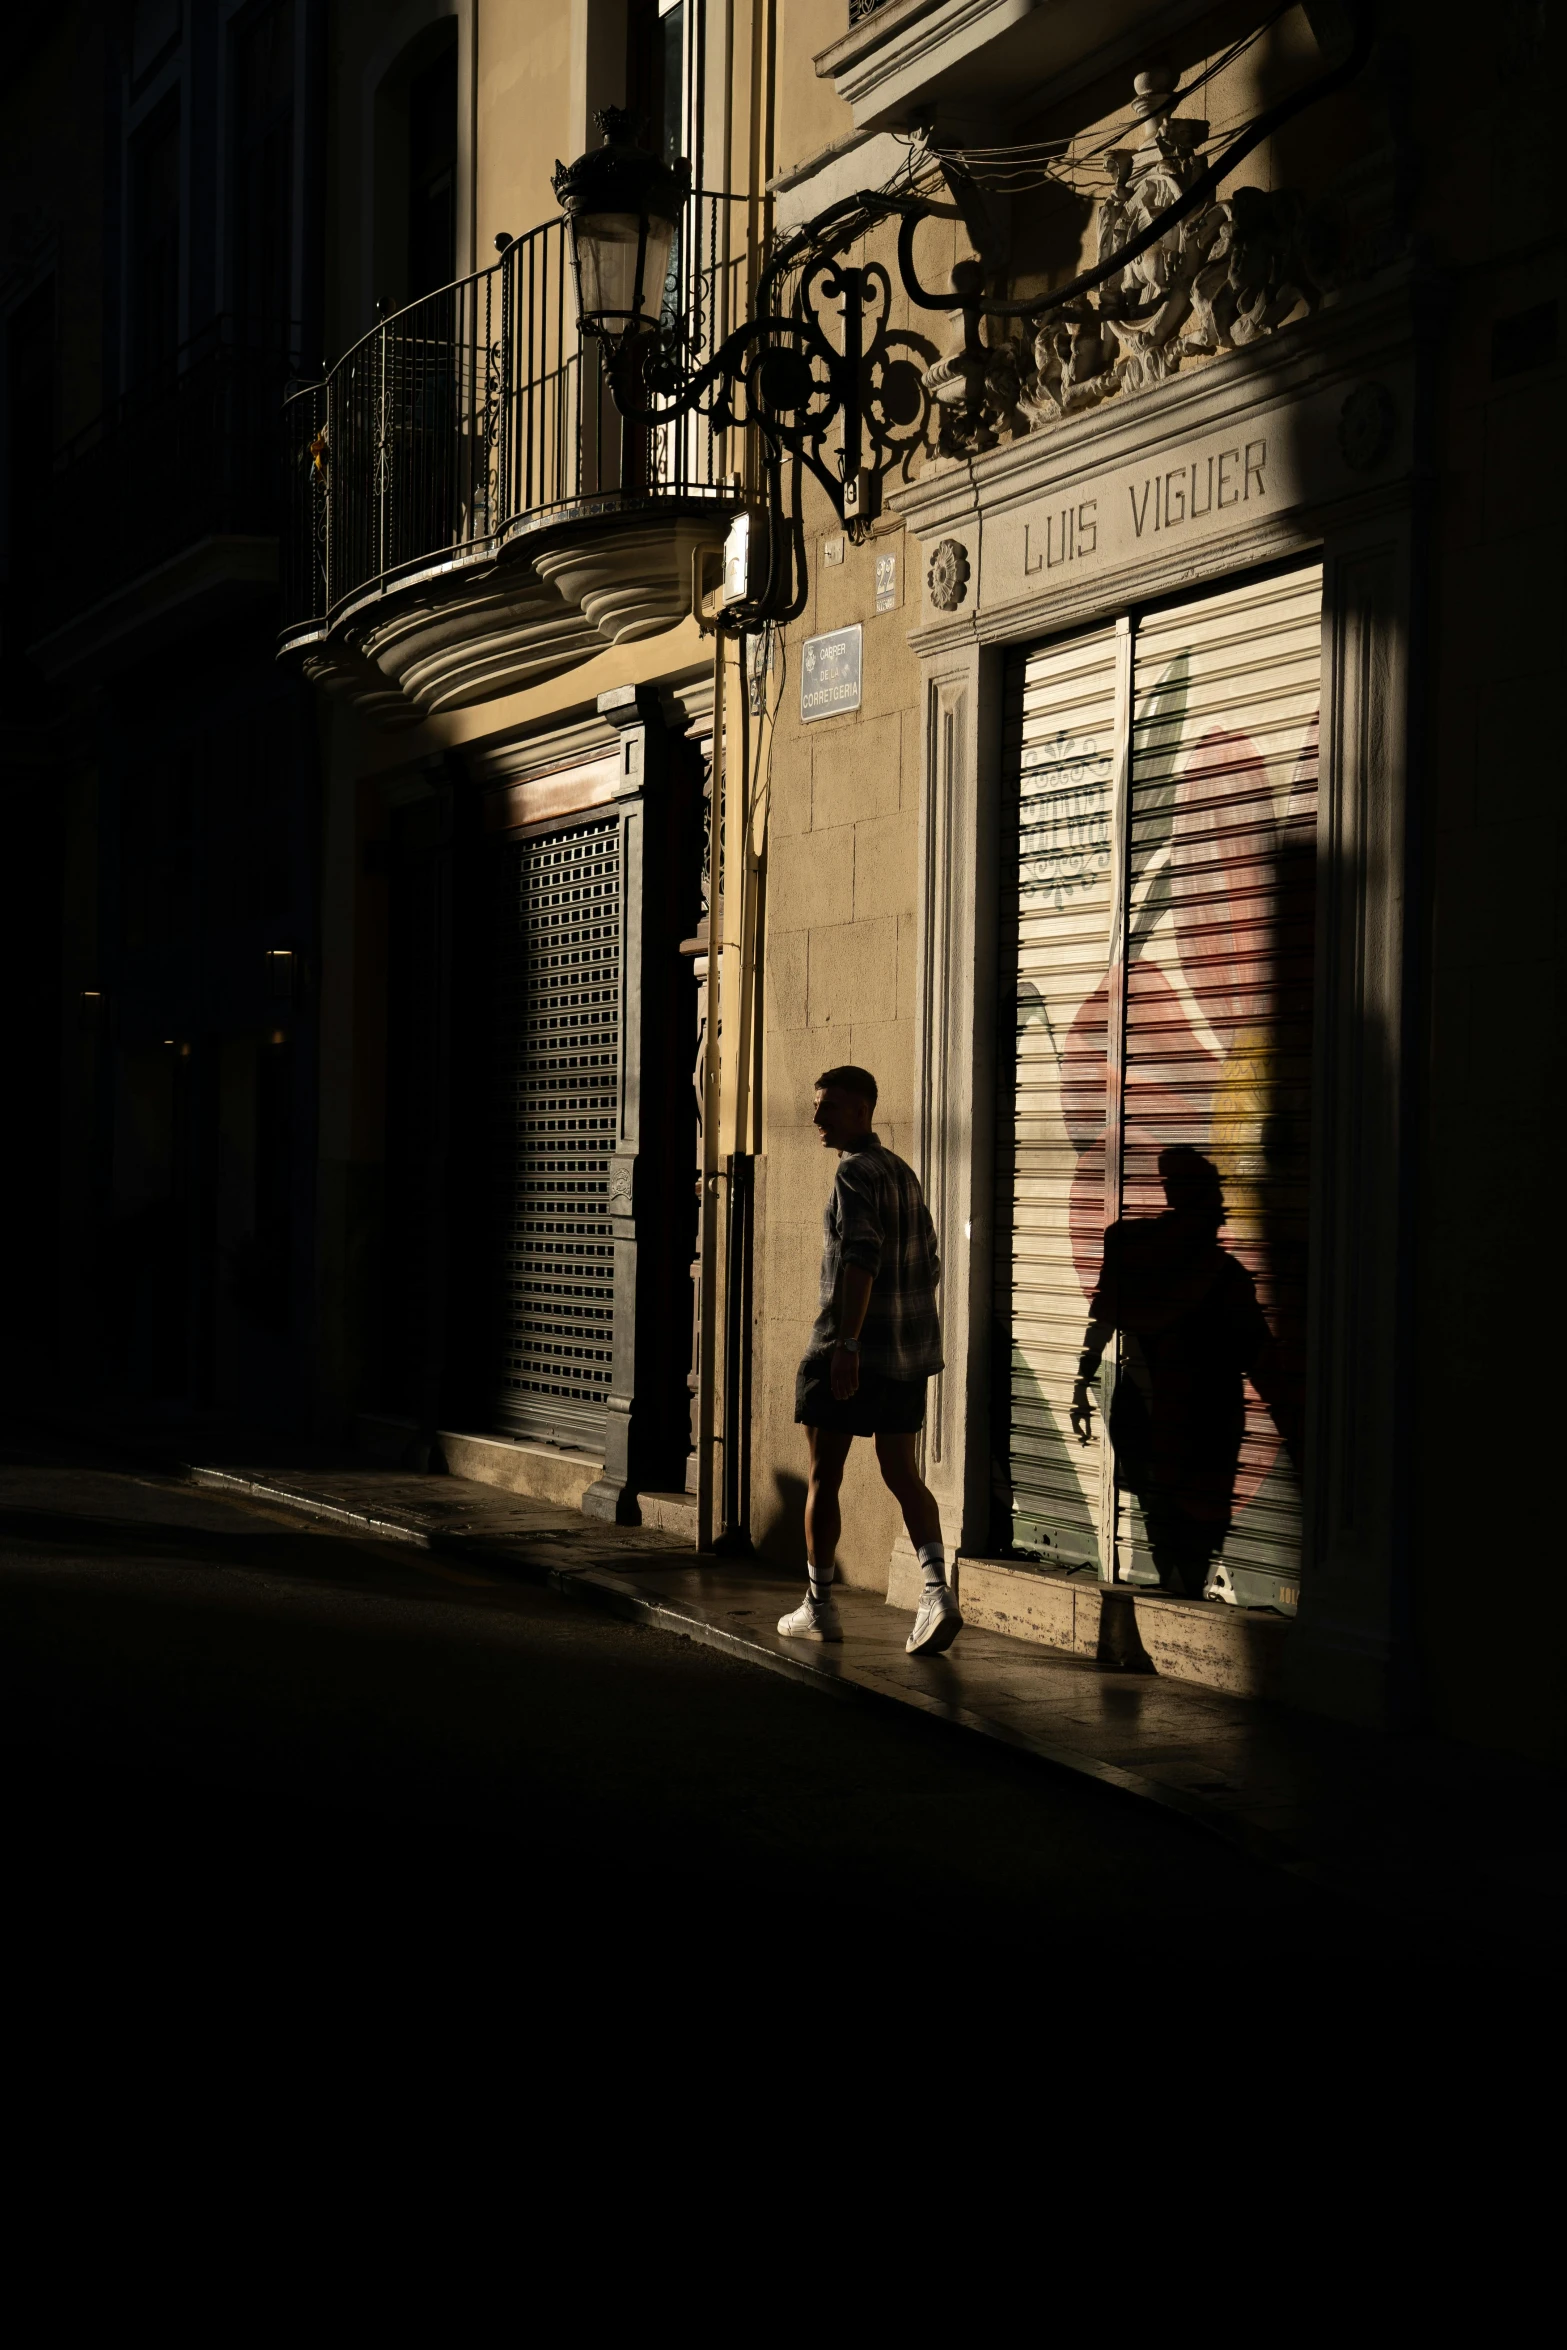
[282,195,742,644]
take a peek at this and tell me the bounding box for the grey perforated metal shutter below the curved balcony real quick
[493,818,620,1450]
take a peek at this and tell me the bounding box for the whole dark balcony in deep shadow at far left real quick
[33,317,294,677]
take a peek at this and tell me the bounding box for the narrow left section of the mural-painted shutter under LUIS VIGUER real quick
[996,627,1116,1565]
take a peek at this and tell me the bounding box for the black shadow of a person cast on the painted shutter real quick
[1071,1144,1297,1598]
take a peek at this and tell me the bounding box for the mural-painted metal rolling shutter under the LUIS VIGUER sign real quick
[998,566,1320,1607]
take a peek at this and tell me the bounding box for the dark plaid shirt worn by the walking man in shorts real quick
[811,1135,942,1379]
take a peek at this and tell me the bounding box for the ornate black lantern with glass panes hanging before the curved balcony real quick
[554,106,691,353]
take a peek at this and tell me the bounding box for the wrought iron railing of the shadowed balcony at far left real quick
[35,317,296,637]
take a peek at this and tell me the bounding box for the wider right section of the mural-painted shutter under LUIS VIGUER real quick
[1121,566,1323,1607]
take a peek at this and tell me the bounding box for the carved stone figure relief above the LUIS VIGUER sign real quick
[923,73,1334,456]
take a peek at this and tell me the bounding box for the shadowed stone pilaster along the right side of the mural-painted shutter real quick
[1294,515,1417,1720]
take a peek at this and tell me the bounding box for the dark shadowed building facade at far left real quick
[0,0,324,1429]
